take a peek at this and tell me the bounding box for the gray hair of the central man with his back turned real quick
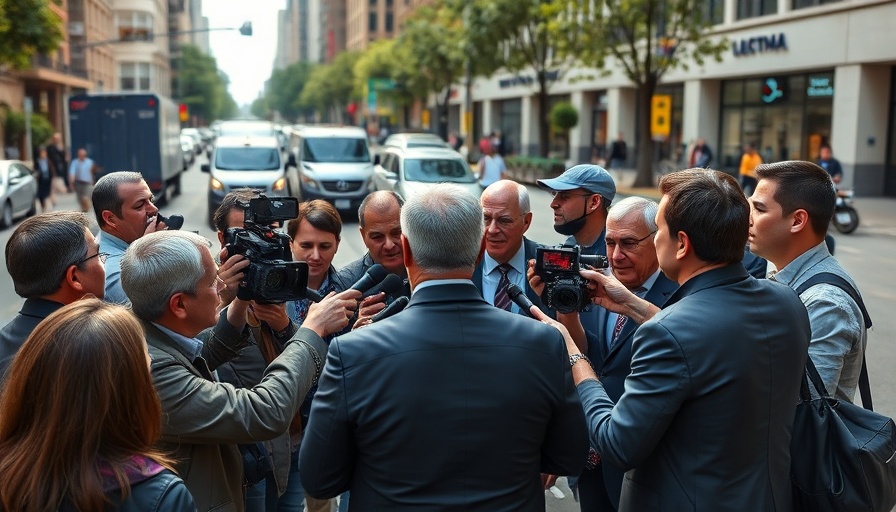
[401,183,485,273]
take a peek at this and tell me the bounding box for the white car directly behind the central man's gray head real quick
[373,147,482,200]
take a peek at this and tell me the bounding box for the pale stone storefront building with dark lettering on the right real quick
[449,0,896,196]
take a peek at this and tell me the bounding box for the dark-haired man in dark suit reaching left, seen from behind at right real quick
[548,169,810,512]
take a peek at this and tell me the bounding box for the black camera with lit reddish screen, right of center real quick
[535,245,609,313]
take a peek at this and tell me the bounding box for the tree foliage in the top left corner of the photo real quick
[0,0,62,69]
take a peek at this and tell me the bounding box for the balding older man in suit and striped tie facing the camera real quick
[473,180,554,316]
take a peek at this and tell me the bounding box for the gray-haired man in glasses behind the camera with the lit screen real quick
[532,196,678,512]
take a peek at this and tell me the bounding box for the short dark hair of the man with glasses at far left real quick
[6,211,90,299]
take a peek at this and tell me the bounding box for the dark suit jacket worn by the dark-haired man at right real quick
[579,263,810,512]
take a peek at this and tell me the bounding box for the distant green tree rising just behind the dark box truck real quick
[172,44,236,123]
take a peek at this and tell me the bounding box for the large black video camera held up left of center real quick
[224,194,308,304]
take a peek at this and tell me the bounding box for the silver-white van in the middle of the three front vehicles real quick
[290,125,374,213]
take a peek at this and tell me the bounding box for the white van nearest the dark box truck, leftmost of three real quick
[202,135,299,225]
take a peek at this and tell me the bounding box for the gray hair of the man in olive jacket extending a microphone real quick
[121,231,211,321]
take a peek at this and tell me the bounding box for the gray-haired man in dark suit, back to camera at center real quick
[299,184,587,511]
